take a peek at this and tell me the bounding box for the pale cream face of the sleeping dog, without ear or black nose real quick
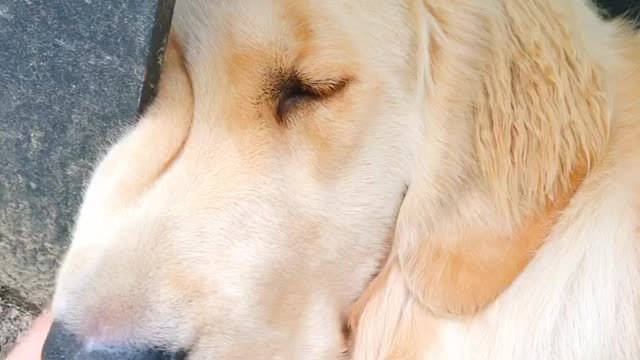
[47,0,423,360]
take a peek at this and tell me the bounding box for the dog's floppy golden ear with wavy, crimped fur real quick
[380,0,609,315]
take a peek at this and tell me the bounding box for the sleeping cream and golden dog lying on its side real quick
[45,0,640,360]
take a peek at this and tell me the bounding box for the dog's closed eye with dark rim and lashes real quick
[276,73,348,122]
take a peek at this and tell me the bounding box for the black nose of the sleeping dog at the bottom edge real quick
[42,322,186,360]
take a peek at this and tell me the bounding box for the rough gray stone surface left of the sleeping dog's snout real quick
[0,0,173,359]
